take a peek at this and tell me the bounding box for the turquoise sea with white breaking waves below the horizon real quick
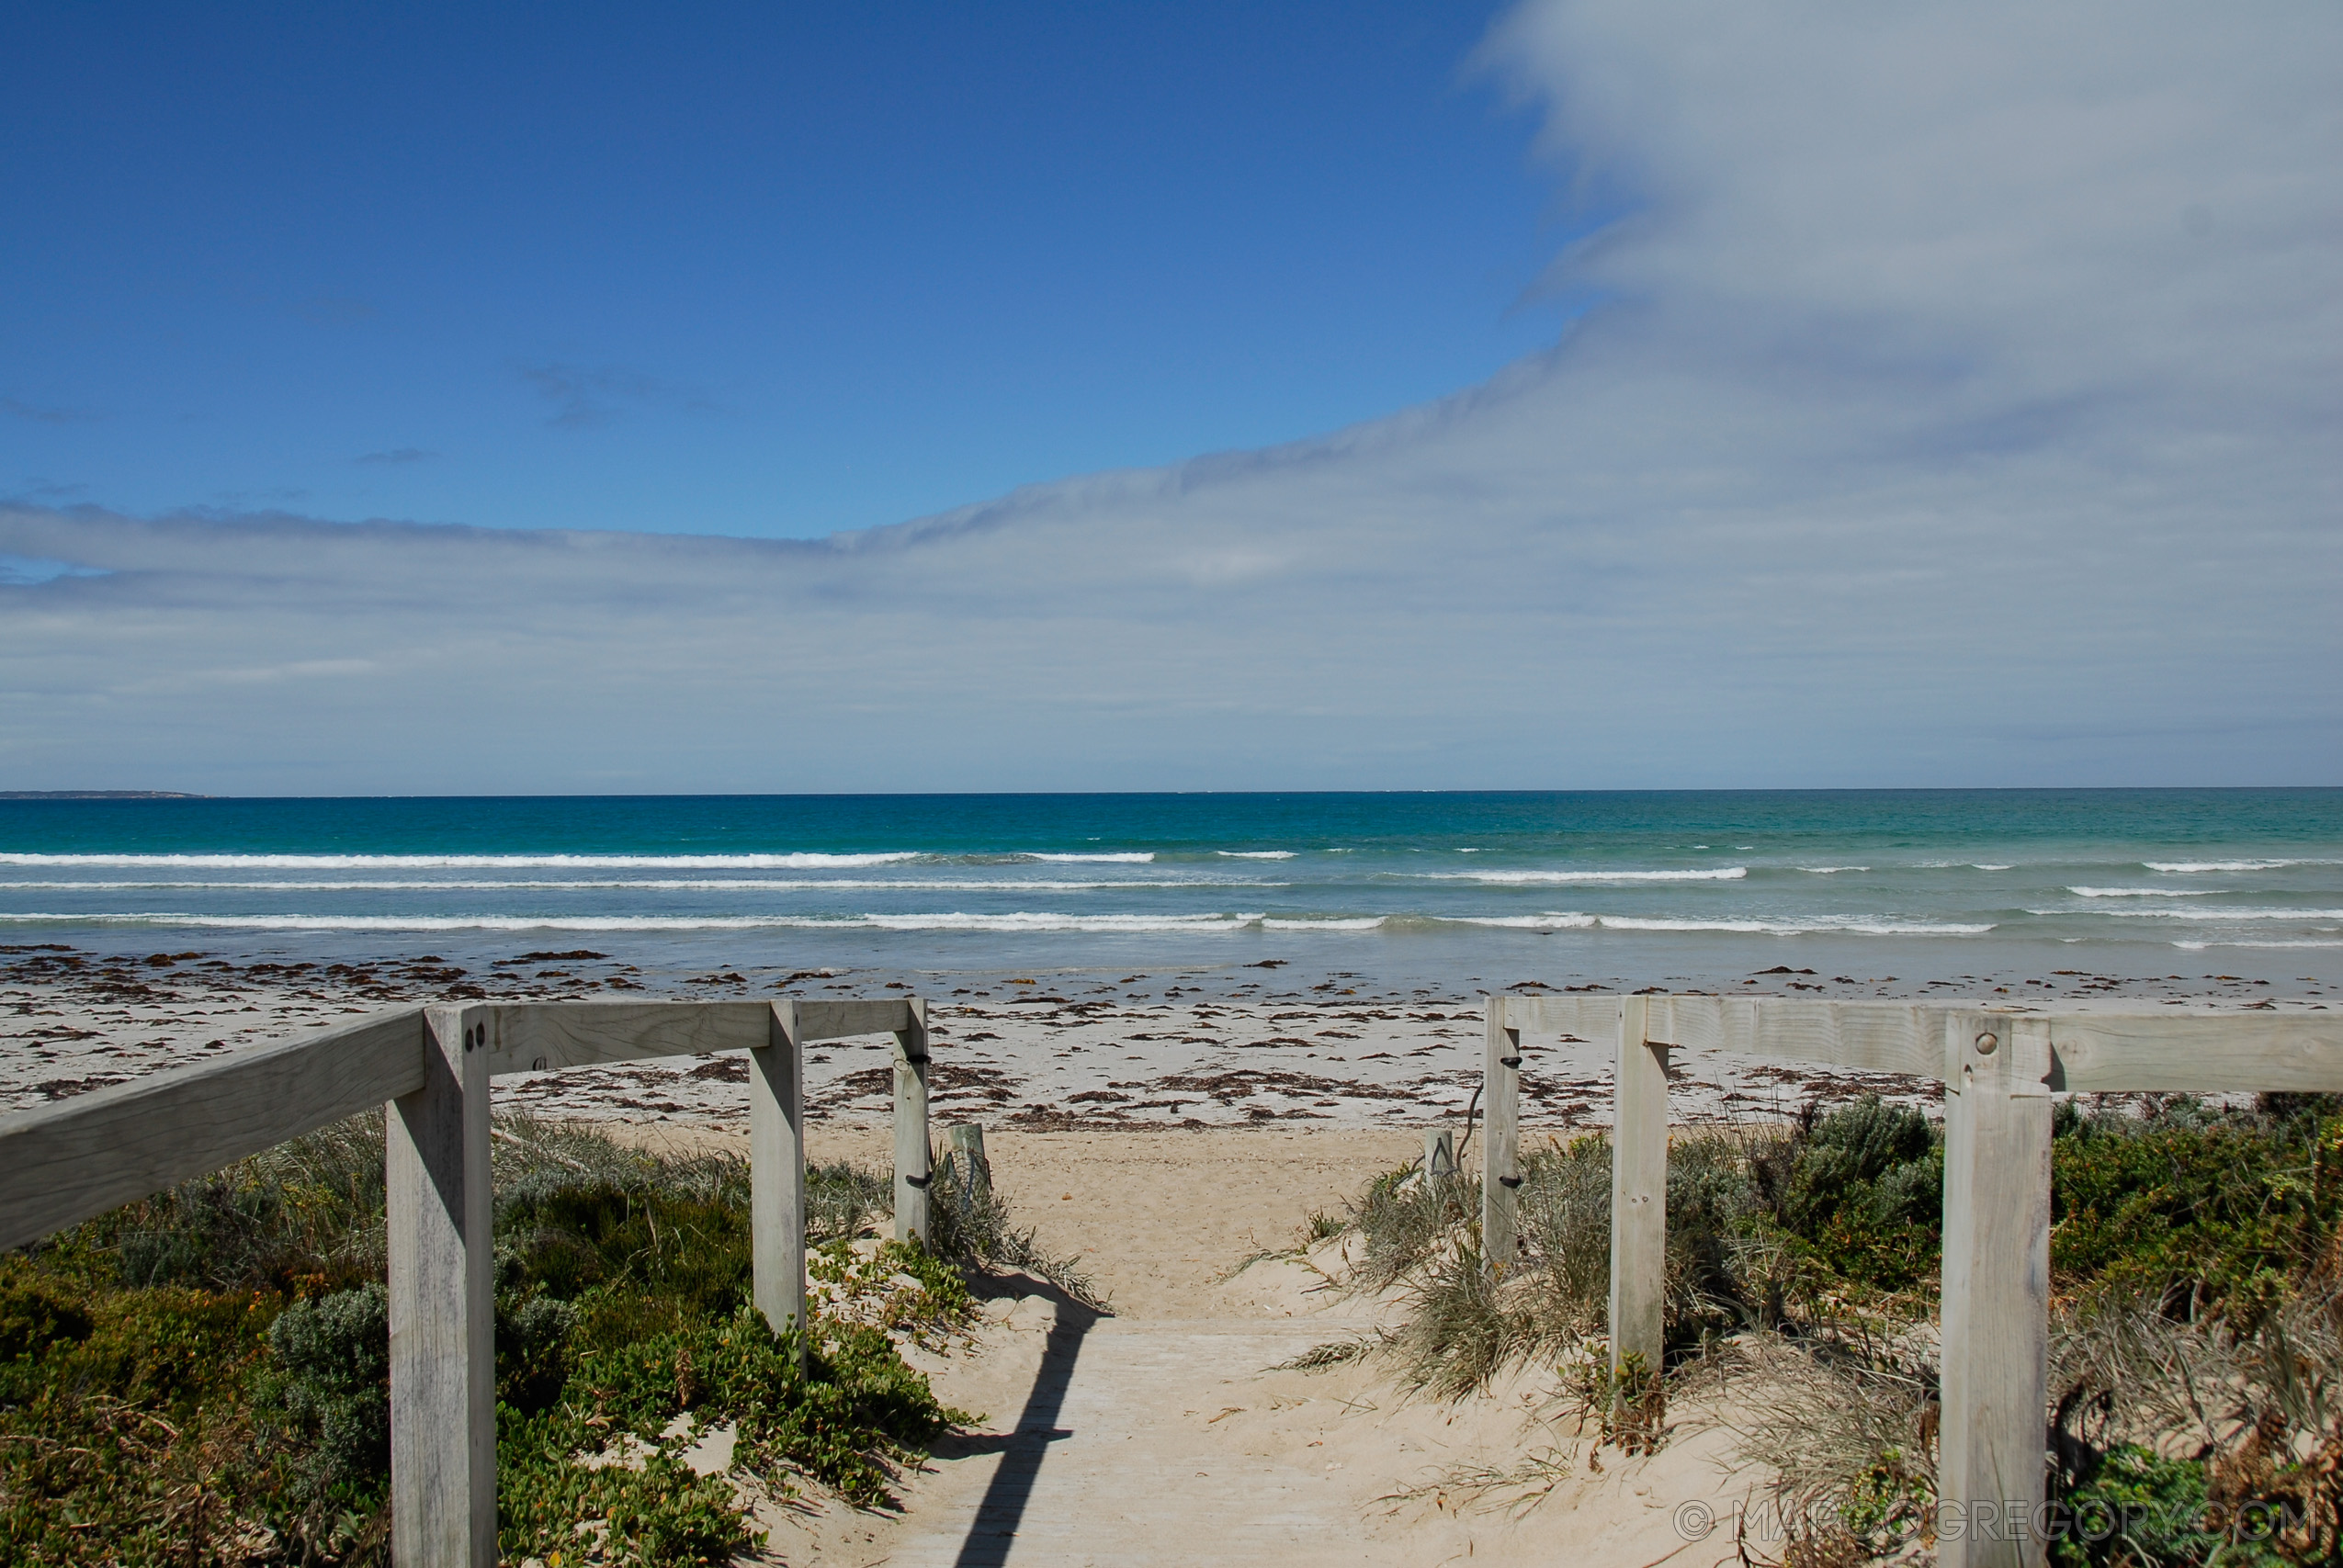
[0,790,2343,982]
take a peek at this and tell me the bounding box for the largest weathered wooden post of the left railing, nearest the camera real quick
[382,1008,497,1568]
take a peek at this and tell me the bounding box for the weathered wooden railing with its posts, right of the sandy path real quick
[1481,996,2343,1568]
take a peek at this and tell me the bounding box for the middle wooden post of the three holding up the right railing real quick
[1610,996,1669,1373]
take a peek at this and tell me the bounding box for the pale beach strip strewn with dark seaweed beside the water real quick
[0,944,2329,1132]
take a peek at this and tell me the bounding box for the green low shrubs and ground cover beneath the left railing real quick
[0,1118,1012,1563]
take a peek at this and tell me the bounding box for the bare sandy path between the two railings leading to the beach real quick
[750,1127,1750,1568]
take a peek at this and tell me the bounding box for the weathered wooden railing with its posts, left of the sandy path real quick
[0,996,930,1568]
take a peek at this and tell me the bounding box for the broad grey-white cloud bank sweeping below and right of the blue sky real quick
[0,3,2343,790]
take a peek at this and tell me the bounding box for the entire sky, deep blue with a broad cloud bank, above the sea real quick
[0,0,2343,795]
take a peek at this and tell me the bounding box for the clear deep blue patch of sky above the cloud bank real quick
[0,3,1590,536]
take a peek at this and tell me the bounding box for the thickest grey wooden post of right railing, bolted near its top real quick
[1935,1012,2050,1568]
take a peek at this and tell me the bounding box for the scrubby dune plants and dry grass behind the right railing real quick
[1329,1095,2343,1565]
